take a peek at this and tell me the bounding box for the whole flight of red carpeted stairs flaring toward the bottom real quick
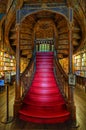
[19,52,70,123]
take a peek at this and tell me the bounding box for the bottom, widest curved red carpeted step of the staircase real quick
[20,110,70,124]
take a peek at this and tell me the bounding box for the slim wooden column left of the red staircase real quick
[14,24,21,117]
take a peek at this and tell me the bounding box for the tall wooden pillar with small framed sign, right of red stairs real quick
[68,7,77,127]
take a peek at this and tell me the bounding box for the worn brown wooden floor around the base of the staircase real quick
[0,86,86,130]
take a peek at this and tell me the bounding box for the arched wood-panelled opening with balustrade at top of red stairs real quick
[34,18,56,52]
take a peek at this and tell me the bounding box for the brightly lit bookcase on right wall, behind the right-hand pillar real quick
[59,51,86,78]
